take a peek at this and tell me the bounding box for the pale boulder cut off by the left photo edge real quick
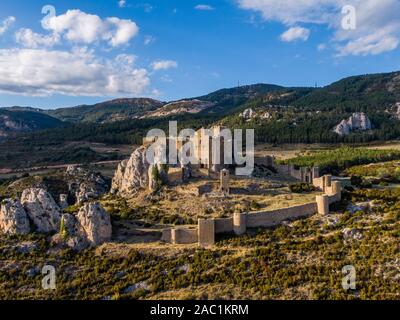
[0,199,30,235]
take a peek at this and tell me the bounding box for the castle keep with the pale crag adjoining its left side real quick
[111,126,239,197]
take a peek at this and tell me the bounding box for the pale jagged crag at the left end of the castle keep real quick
[111,146,150,197]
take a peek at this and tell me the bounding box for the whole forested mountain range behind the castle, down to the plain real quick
[3,72,400,143]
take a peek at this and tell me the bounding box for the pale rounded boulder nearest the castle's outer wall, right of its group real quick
[76,203,112,246]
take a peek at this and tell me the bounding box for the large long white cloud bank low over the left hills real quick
[0,49,150,96]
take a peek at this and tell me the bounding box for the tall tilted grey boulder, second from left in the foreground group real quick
[21,188,61,233]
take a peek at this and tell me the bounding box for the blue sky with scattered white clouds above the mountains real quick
[0,0,400,109]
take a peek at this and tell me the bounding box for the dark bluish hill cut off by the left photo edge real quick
[0,107,66,138]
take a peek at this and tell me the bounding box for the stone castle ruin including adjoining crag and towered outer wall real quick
[112,127,342,247]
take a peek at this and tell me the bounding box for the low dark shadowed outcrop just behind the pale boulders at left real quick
[65,166,108,204]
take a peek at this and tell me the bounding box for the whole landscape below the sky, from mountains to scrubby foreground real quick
[0,73,400,300]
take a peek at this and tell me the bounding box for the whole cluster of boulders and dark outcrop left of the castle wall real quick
[0,166,112,250]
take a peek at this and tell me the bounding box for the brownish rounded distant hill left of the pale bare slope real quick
[44,98,165,123]
